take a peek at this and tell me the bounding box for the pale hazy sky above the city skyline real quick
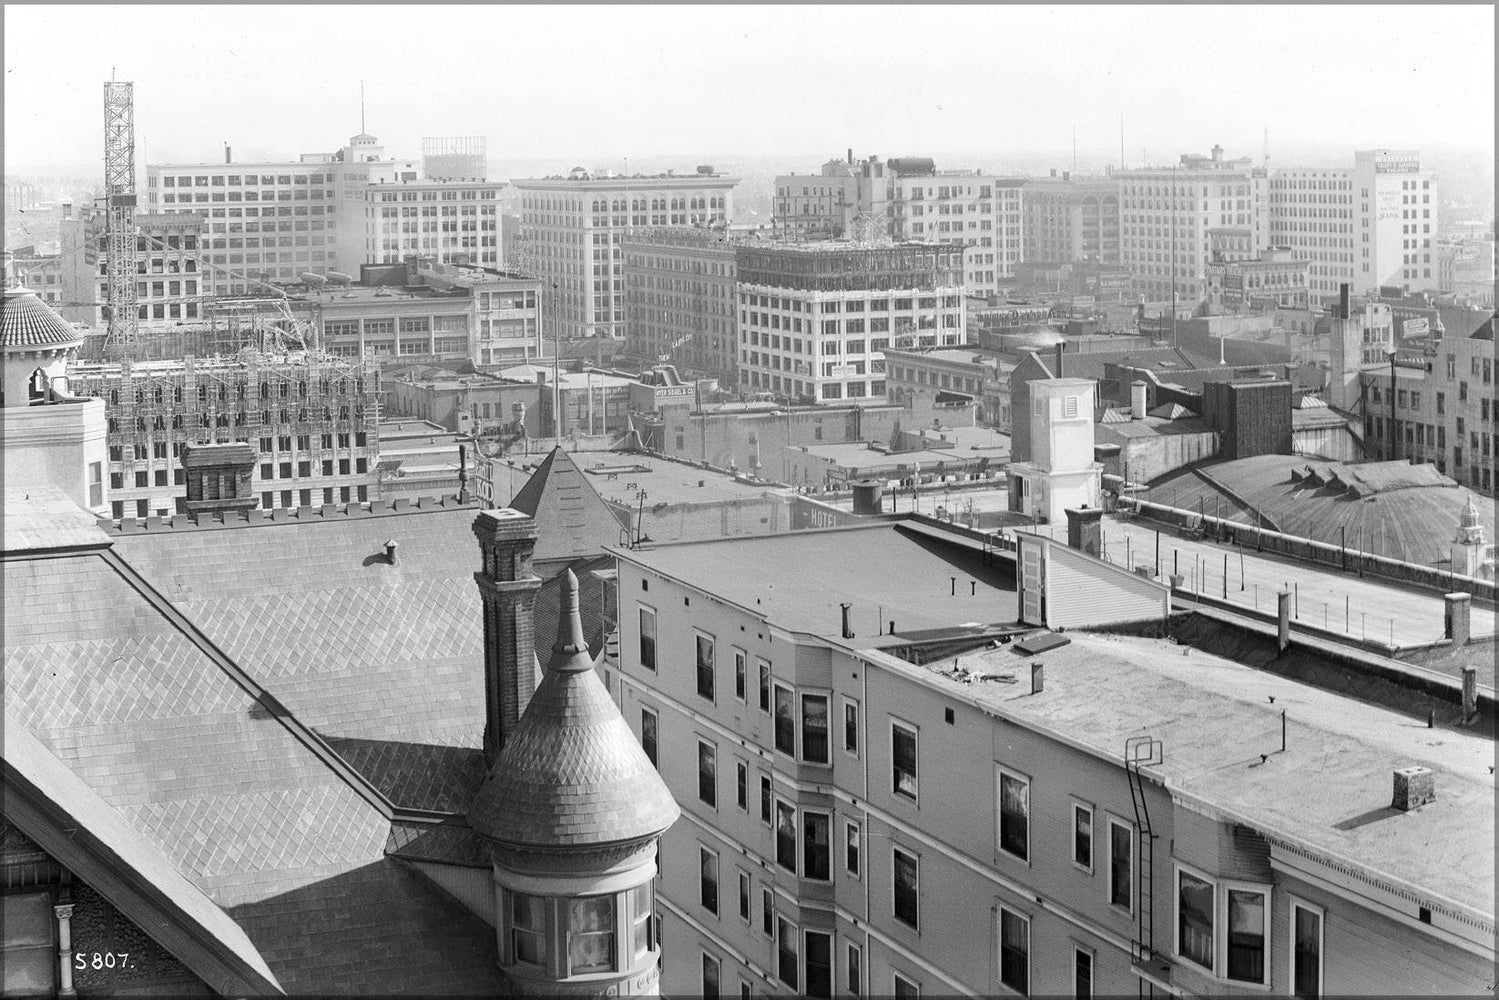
[4,3,1495,172]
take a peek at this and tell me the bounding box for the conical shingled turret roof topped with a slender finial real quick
[468,570,681,847]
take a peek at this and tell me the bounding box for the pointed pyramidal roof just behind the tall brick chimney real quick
[510,447,624,562]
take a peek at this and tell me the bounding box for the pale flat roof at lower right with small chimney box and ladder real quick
[898,633,1495,921]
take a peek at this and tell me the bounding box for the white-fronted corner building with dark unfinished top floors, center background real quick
[736,241,965,403]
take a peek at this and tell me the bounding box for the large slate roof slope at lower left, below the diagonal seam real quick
[3,548,498,994]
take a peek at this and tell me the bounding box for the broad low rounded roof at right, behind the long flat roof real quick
[1142,454,1495,564]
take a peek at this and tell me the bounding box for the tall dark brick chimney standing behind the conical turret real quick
[474,508,541,765]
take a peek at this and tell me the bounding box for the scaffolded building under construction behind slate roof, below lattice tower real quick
[69,358,379,517]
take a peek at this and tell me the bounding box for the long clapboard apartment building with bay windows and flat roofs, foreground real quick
[604,519,1493,997]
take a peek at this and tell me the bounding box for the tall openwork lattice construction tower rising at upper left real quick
[103,79,136,352]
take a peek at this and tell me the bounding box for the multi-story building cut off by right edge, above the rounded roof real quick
[1360,319,1499,496]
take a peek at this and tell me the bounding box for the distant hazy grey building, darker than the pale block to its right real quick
[1021,171,1120,264]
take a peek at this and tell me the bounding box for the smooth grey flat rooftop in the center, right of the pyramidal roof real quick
[612,520,1016,637]
